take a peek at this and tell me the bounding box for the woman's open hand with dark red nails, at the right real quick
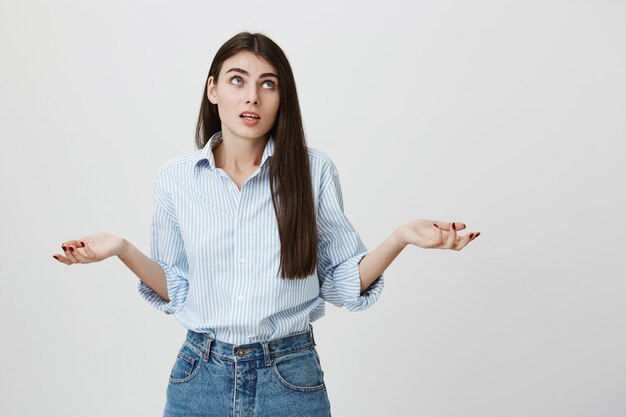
[397,219,480,251]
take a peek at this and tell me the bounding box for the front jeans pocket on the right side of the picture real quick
[272,347,325,392]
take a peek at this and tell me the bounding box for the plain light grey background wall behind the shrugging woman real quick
[0,0,626,417]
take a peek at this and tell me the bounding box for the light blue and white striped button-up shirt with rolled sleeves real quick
[137,132,384,345]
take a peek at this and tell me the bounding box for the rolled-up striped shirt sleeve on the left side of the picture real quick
[137,169,189,314]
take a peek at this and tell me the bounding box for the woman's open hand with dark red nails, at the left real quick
[52,233,127,265]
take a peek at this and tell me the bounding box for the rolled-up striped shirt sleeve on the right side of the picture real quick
[317,162,384,311]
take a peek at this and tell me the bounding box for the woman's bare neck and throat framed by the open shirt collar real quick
[212,131,269,173]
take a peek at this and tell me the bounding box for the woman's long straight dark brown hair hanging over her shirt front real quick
[196,32,318,279]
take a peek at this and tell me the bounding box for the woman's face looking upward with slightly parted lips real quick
[207,51,280,139]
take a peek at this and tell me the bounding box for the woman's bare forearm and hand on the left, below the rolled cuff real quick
[52,233,170,303]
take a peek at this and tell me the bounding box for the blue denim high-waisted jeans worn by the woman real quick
[163,326,331,417]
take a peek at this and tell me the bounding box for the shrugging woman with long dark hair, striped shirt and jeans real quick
[54,32,479,417]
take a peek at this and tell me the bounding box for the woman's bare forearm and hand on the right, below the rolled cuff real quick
[359,220,480,295]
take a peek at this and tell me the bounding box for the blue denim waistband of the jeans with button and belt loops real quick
[187,324,316,366]
